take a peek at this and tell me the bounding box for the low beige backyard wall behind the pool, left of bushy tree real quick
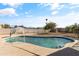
[0,28,44,35]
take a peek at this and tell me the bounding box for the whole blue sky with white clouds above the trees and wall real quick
[0,3,79,27]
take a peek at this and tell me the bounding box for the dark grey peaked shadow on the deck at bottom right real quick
[48,47,79,56]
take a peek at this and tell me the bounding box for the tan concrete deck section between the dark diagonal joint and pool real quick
[13,42,59,56]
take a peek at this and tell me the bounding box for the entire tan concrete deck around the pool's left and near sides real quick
[0,35,76,56]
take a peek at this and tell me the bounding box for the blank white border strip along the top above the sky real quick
[0,0,79,4]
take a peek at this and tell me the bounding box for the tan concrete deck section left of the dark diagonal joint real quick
[0,35,34,56]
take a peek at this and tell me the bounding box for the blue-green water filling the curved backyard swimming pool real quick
[5,36,74,48]
